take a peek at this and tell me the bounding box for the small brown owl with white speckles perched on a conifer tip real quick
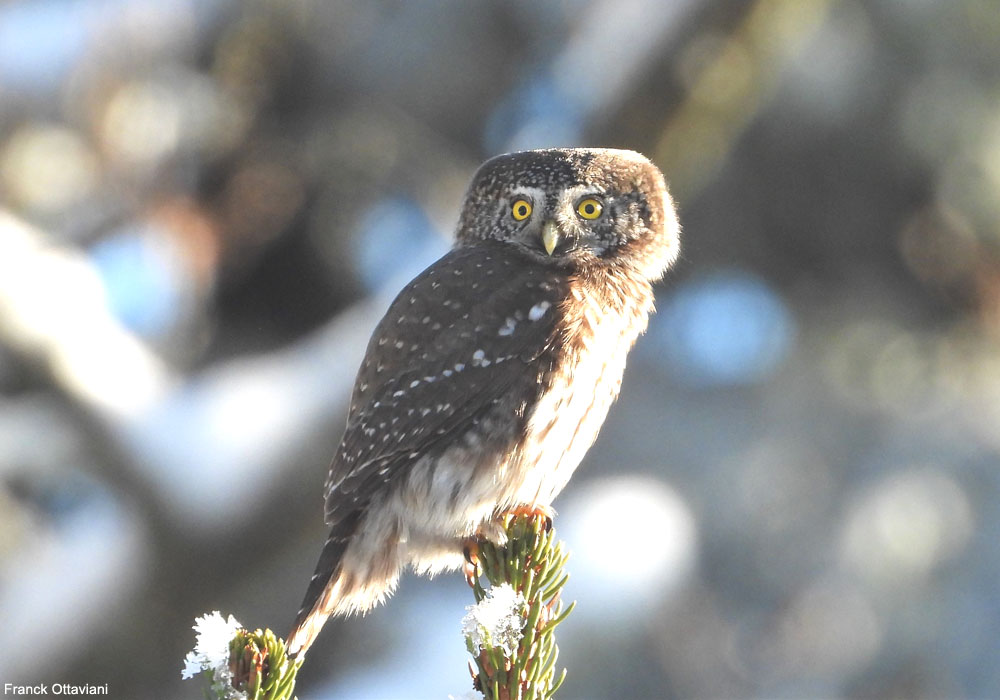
[288,149,680,654]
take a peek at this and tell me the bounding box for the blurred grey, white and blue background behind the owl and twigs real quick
[0,0,1000,699]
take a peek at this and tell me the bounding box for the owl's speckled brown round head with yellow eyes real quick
[456,148,680,281]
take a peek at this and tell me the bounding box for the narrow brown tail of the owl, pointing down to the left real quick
[286,514,358,657]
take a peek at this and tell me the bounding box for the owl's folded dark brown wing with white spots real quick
[326,241,568,525]
